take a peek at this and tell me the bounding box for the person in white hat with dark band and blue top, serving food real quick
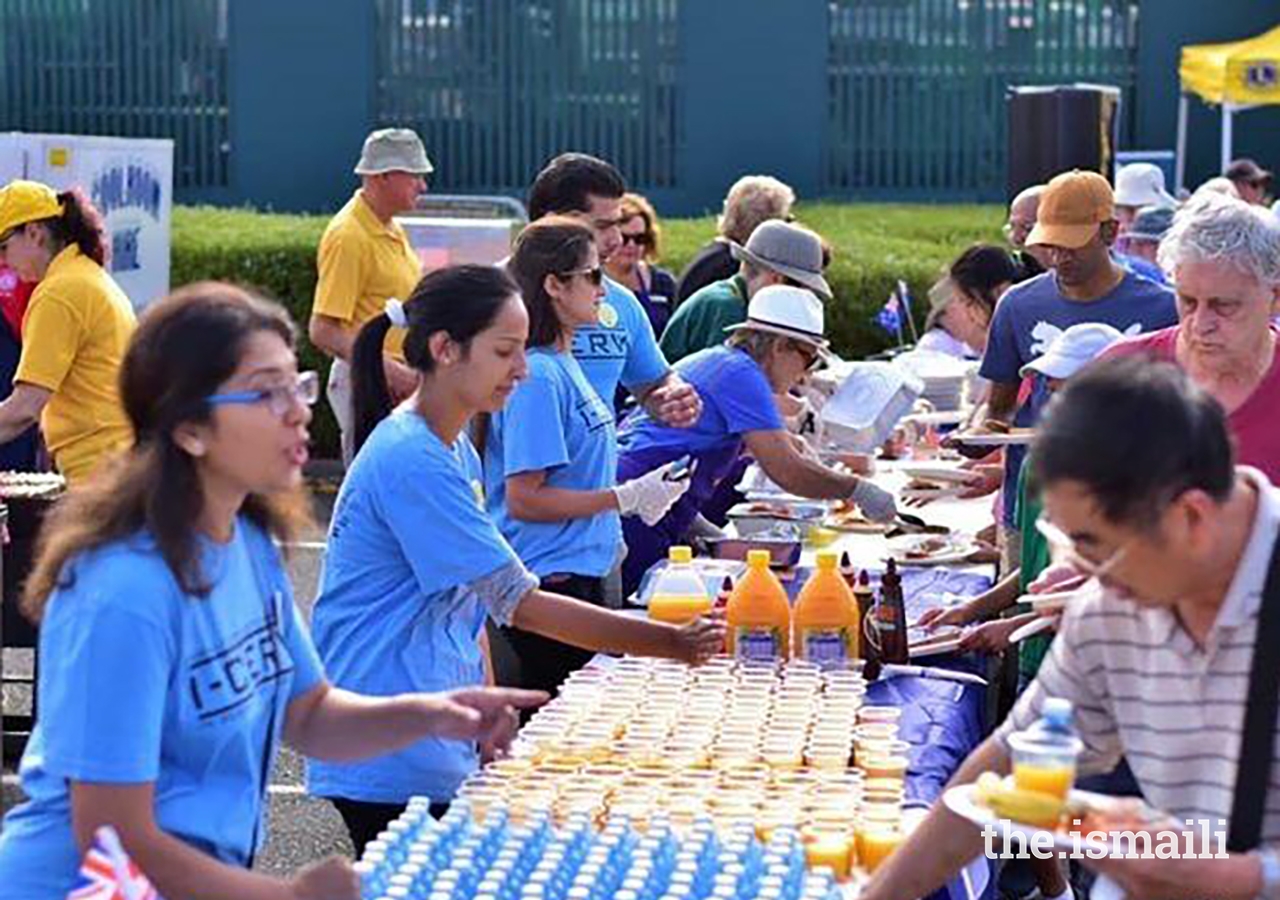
[618,289,897,593]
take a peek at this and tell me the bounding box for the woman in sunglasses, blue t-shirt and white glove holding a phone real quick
[484,216,689,690]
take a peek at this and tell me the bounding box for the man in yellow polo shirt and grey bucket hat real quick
[307,128,433,461]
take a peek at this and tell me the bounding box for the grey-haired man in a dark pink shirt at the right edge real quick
[1107,195,1280,483]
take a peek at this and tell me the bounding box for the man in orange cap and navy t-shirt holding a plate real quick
[959,170,1178,558]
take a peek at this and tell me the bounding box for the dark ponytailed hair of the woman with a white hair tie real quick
[351,265,520,452]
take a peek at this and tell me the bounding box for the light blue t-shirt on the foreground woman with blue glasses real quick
[0,517,324,900]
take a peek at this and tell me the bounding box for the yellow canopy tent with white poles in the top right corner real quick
[1178,26,1280,188]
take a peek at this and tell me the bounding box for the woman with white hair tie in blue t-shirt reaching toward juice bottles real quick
[307,265,723,848]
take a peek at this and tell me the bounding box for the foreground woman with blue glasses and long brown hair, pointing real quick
[0,283,544,900]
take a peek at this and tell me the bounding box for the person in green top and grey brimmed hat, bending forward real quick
[660,219,831,362]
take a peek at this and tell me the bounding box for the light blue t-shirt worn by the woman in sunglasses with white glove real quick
[484,347,622,577]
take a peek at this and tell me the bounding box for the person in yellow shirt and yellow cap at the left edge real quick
[0,181,136,484]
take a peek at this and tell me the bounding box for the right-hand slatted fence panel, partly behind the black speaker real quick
[823,0,1138,198]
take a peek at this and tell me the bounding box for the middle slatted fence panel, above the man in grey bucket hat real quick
[375,0,680,191]
